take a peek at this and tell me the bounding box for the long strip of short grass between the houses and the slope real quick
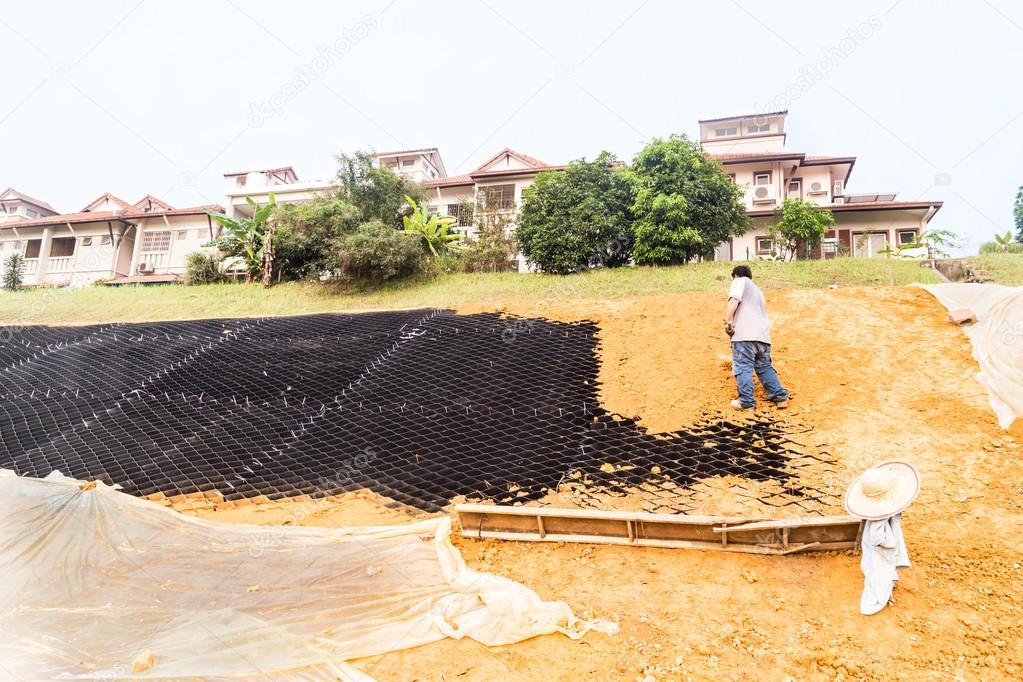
[0,259,938,325]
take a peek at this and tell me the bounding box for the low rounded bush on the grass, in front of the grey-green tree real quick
[329,221,427,284]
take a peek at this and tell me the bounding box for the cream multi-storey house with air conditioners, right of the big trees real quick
[700,111,941,261]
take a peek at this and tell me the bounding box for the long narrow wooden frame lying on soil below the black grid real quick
[454,504,862,555]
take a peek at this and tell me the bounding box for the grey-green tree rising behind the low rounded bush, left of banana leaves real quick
[338,151,427,229]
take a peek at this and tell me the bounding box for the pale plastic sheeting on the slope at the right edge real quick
[924,284,1023,428]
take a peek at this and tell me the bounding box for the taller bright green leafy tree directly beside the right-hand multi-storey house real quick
[631,135,750,265]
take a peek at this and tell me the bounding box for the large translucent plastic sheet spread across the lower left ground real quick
[0,470,617,680]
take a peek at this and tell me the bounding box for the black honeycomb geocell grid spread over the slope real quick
[0,310,837,513]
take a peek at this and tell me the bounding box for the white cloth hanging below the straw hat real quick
[859,513,909,616]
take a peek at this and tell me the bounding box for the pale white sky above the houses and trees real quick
[0,0,1023,253]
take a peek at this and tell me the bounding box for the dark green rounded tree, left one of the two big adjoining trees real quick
[516,151,635,274]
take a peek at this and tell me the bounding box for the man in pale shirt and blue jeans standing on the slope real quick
[724,265,789,412]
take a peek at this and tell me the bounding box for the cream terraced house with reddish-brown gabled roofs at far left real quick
[0,193,223,286]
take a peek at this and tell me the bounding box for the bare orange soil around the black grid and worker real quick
[180,287,1023,681]
